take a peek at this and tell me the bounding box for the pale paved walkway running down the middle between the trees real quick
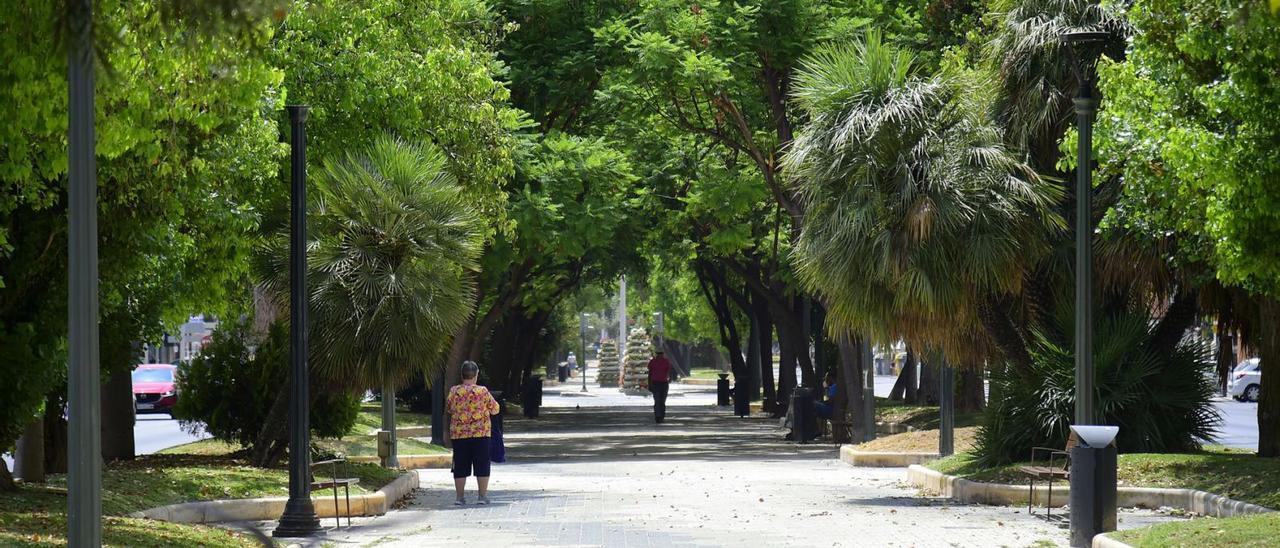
[272,373,1166,547]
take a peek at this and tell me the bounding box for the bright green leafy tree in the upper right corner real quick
[1098,0,1280,457]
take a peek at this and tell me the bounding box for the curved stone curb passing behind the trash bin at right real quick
[906,465,1274,517]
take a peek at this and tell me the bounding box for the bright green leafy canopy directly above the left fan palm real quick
[270,0,524,224]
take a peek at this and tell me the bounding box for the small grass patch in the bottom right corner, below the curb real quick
[1107,513,1280,548]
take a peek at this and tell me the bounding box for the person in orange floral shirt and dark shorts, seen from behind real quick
[445,361,500,506]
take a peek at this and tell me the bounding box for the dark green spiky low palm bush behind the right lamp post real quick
[975,309,1220,466]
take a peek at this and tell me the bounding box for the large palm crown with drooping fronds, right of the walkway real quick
[785,33,1061,364]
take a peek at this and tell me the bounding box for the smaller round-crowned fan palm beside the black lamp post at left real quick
[257,137,481,466]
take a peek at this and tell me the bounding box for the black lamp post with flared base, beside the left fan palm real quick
[271,105,320,536]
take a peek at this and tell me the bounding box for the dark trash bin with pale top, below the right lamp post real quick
[1069,426,1120,547]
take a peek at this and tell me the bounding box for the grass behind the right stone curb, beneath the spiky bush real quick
[928,446,1280,508]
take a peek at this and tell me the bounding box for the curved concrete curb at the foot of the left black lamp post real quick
[129,471,417,524]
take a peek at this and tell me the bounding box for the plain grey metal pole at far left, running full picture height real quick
[67,0,102,548]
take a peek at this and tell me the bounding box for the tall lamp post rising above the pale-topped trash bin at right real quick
[1062,31,1111,425]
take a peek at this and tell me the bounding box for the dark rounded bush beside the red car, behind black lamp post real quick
[173,321,360,447]
